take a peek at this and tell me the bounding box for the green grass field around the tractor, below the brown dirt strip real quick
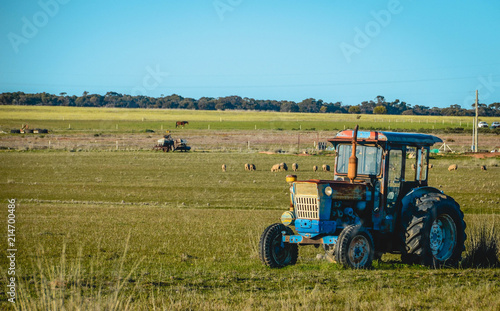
[0,151,500,310]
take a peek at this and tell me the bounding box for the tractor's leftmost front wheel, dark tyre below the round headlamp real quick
[259,224,299,268]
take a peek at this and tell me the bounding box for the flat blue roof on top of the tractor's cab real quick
[328,130,442,146]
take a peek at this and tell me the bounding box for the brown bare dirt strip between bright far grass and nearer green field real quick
[0,130,499,157]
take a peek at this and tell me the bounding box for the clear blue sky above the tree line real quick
[0,0,500,108]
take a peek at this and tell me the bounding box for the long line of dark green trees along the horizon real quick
[0,92,500,116]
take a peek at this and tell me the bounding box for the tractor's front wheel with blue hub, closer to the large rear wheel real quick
[335,225,375,269]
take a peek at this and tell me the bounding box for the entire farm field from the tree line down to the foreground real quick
[0,106,500,310]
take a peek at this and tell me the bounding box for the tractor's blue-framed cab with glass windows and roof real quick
[329,130,442,232]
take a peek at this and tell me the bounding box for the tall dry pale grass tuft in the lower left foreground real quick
[14,234,142,310]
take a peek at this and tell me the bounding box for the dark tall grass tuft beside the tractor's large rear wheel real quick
[462,223,500,268]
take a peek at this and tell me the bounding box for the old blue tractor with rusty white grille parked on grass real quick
[259,126,466,269]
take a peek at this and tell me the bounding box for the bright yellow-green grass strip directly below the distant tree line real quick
[0,106,496,133]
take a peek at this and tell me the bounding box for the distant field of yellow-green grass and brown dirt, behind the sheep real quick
[0,106,500,153]
